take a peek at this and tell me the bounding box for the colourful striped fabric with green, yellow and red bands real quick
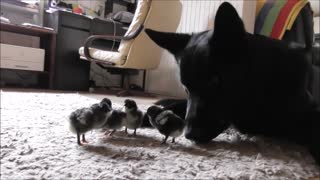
[254,0,308,39]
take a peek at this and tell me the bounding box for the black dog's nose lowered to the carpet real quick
[185,128,212,143]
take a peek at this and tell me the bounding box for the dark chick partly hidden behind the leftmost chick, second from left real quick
[103,110,127,136]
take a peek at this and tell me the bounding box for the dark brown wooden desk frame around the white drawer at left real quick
[0,23,56,88]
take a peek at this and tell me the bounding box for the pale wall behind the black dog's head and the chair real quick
[147,0,255,97]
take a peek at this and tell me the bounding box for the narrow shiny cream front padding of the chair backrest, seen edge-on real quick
[118,0,151,56]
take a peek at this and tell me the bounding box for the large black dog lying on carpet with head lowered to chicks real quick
[145,3,320,163]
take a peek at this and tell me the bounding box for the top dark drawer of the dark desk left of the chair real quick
[60,12,91,31]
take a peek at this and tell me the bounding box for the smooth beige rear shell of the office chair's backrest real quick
[118,0,182,69]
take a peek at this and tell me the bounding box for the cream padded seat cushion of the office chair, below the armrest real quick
[79,47,127,65]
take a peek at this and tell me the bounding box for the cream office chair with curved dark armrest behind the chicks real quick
[79,0,182,95]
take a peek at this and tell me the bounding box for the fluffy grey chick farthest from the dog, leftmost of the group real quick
[69,103,111,145]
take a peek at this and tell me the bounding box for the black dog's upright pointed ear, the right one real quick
[212,2,246,43]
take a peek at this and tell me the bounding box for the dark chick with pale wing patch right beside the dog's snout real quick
[147,106,185,144]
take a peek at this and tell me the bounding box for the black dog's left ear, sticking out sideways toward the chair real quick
[145,29,191,55]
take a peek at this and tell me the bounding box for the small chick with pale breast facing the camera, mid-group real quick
[124,99,143,136]
